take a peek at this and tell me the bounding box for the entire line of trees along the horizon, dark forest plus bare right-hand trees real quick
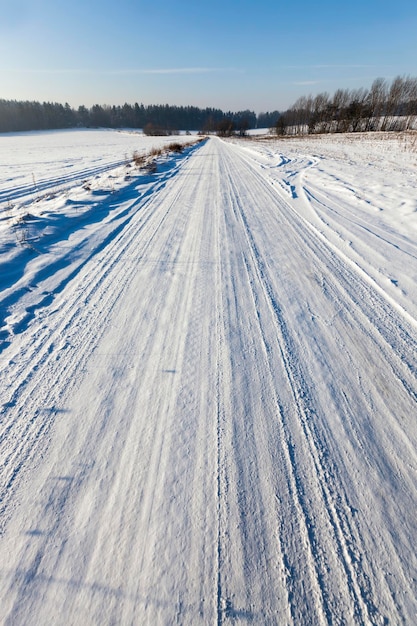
[0,76,417,136]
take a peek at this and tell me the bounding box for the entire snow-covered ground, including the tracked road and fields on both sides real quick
[0,130,417,626]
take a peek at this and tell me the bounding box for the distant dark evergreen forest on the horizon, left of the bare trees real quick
[0,100,279,134]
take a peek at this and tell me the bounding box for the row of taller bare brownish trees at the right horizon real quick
[275,76,417,135]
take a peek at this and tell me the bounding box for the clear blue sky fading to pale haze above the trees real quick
[0,0,417,112]
